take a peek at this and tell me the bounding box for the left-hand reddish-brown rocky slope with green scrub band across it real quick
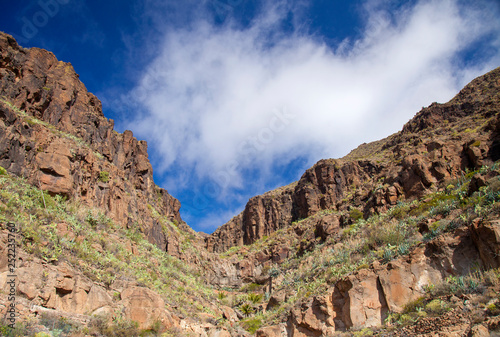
[0,33,234,334]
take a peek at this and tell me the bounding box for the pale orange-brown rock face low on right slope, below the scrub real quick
[287,229,486,336]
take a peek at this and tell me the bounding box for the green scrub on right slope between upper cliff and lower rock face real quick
[231,160,500,324]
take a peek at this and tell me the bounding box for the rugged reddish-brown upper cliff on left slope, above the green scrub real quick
[0,33,182,255]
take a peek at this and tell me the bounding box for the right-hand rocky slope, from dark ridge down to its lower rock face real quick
[206,65,500,336]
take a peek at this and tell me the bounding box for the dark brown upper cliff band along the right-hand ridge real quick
[206,69,500,252]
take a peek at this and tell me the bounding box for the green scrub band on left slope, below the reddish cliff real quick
[0,175,219,324]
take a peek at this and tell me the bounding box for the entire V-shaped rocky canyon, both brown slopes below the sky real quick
[0,33,500,337]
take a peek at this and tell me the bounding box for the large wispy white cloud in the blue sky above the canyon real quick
[127,0,500,202]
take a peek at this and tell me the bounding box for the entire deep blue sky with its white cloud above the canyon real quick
[0,0,500,233]
